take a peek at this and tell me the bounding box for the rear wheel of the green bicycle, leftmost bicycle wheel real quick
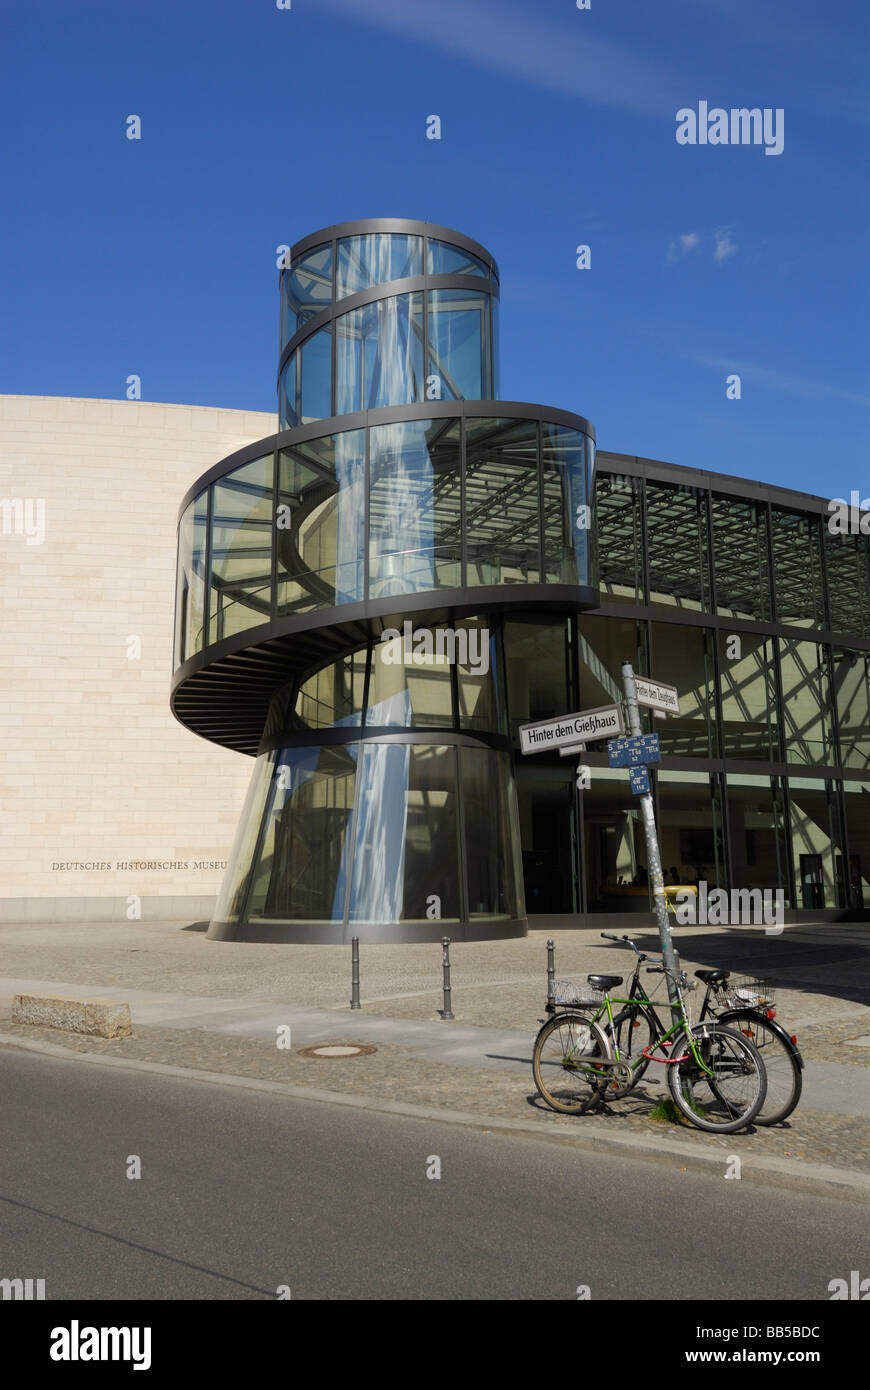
[532,1013,612,1115]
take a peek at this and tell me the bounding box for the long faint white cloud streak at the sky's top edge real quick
[320,0,681,118]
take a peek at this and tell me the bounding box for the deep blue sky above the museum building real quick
[0,0,870,496]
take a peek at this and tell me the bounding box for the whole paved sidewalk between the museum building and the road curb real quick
[0,923,870,1180]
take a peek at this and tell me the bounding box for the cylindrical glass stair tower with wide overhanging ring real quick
[172,218,598,941]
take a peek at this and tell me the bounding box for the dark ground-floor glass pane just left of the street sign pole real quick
[582,767,650,912]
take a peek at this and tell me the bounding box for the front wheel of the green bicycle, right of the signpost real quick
[667,1023,767,1134]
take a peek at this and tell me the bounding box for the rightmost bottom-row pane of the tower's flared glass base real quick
[460,748,525,922]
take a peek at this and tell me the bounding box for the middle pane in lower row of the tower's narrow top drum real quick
[335,295,422,416]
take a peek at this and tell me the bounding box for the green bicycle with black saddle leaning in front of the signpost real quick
[532,933,767,1134]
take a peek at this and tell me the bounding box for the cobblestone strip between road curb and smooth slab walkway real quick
[0,1016,870,1173]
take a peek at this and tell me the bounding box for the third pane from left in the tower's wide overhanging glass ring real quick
[275,430,366,613]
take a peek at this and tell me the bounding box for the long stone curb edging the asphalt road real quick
[0,1031,870,1204]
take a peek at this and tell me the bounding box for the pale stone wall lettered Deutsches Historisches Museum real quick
[0,396,277,922]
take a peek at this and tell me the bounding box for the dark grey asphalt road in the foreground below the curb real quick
[0,1049,870,1301]
